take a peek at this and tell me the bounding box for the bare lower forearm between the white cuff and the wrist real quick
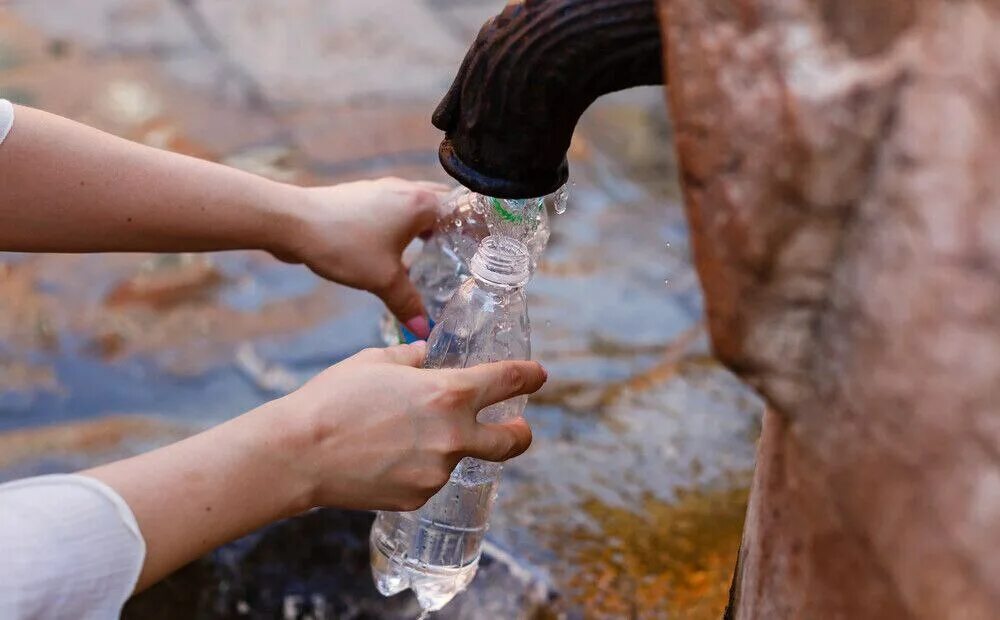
[83,401,313,591]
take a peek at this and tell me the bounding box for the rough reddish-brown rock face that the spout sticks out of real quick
[658,0,1000,618]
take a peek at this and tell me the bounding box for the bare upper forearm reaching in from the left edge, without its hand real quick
[0,106,297,252]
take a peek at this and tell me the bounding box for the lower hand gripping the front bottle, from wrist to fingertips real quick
[273,342,546,510]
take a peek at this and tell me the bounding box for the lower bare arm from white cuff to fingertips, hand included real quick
[84,343,545,590]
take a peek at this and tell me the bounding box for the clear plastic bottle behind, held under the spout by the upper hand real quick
[381,186,568,345]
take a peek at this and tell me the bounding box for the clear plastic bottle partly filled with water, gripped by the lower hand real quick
[370,236,531,611]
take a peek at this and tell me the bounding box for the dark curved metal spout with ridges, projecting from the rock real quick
[433,0,663,198]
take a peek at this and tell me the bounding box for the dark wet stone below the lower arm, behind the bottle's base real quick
[123,510,555,620]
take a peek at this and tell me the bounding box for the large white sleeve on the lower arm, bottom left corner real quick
[0,475,146,620]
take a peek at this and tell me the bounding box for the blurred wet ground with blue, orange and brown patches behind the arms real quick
[0,0,761,618]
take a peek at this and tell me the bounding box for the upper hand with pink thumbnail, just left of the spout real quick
[275,177,449,338]
